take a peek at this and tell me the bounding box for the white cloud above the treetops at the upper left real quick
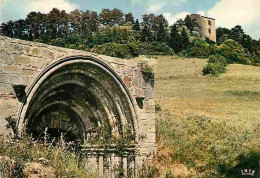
[27,0,77,13]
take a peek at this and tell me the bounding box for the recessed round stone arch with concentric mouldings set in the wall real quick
[18,56,139,145]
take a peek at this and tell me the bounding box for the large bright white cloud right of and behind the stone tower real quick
[207,0,260,38]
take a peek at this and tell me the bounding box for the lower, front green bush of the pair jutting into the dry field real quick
[202,63,226,76]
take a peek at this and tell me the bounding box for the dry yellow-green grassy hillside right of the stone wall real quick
[155,57,260,176]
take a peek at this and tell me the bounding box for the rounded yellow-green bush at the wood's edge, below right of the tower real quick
[217,39,250,64]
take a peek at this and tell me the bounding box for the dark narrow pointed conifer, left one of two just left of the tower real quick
[169,24,182,53]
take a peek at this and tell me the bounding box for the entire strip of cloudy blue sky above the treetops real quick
[0,0,260,39]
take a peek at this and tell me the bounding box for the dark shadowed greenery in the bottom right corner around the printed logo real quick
[218,151,260,178]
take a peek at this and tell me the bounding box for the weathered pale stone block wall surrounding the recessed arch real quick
[0,36,156,177]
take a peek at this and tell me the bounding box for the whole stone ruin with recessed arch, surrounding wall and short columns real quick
[0,36,157,175]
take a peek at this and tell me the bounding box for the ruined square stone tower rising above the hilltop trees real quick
[190,14,216,42]
